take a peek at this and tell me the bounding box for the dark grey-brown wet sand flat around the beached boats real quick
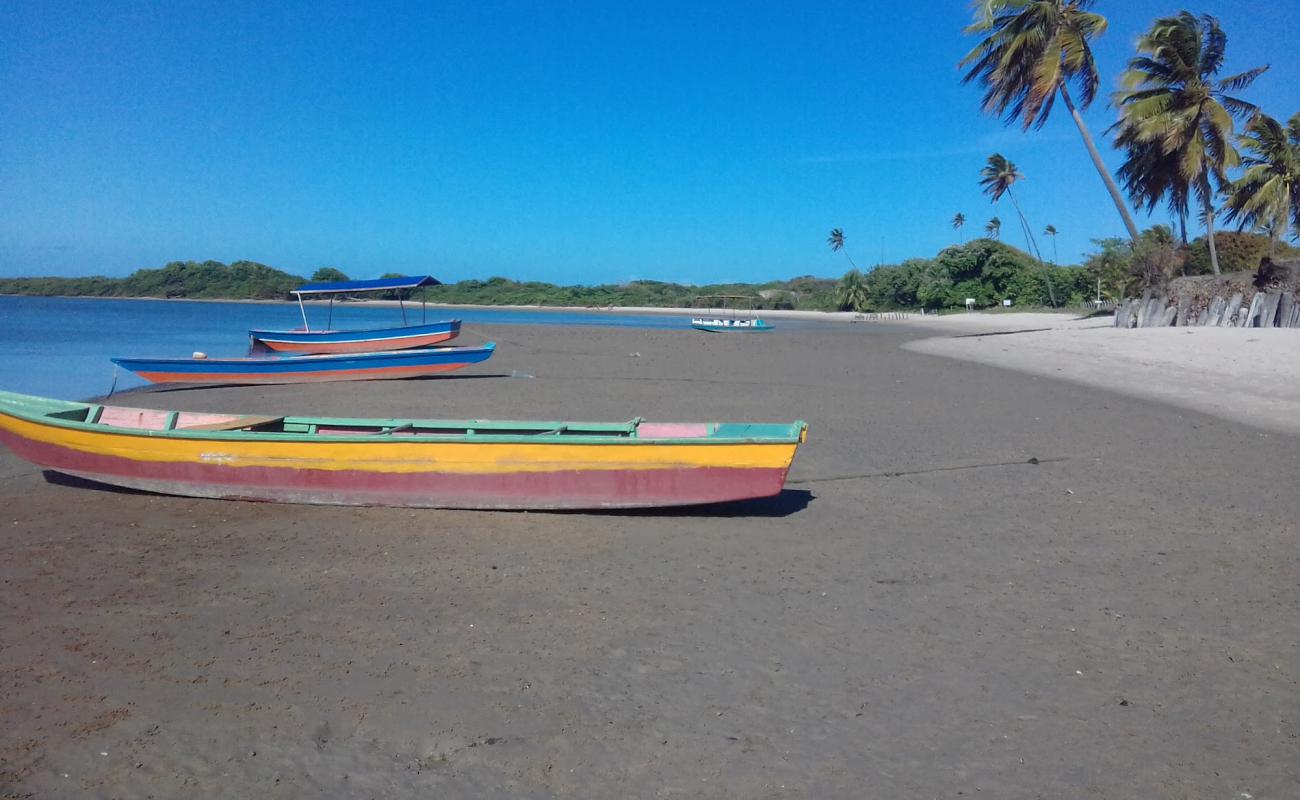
[0,317,1300,799]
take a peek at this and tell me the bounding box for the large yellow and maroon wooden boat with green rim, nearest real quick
[0,392,807,509]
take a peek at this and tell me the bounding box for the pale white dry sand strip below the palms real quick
[905,313,1300,433]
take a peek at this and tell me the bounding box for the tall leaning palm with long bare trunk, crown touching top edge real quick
[958,0,1138,242]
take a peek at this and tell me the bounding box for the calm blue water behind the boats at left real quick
[0,297,823,399]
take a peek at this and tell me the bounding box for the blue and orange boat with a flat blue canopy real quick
[248,274,460,354]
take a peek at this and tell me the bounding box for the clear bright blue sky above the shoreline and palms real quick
[0,0,1300,284]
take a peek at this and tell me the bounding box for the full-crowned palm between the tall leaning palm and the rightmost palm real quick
[1114,12,1269,274]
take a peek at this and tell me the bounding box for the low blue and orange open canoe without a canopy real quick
[112,342,497,384]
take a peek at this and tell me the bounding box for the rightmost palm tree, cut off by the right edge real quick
[1226,113,1300,255]
